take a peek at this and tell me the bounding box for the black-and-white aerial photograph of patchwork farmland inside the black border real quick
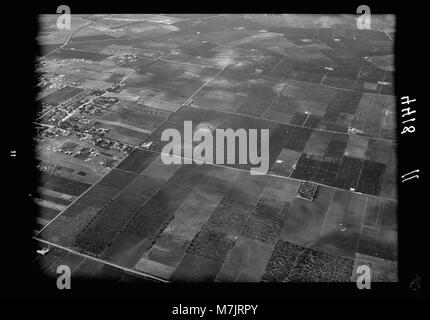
[32,13,398,283]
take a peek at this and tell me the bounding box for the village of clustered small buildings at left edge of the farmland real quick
[36,66,136,171]
